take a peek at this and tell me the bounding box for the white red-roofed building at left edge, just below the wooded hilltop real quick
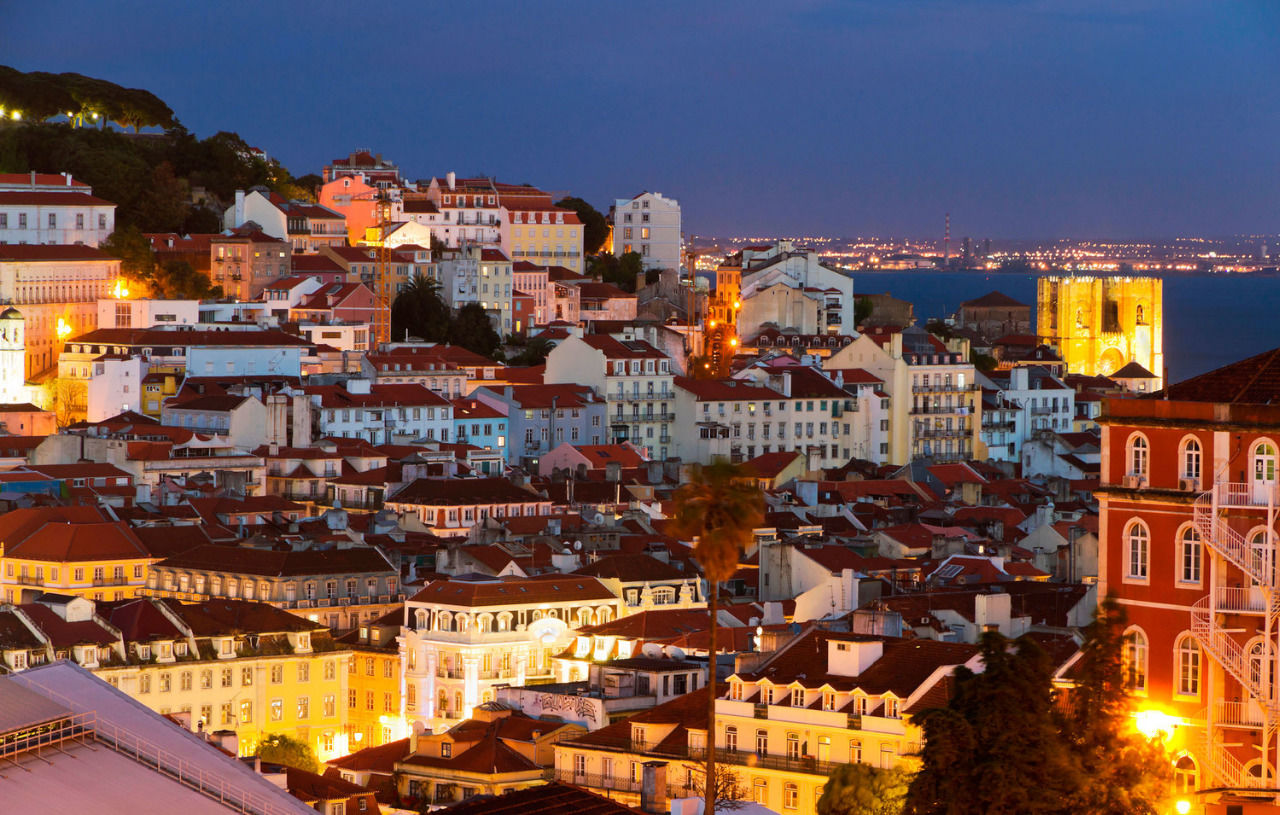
[0,173,115,247]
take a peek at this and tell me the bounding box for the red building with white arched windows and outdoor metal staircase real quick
[1100,352,1280,811]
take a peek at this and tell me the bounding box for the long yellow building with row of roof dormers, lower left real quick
[0,595,351,760]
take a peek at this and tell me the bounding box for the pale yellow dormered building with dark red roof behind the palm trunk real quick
[556,628,978,814]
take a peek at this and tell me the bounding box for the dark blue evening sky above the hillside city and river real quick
[0,0,1280,238]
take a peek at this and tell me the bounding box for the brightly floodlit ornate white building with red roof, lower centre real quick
[399,574,620,727]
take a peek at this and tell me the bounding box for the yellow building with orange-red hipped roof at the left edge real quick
[0,501,157,603]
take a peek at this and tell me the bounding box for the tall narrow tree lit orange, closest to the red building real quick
[1066,597,1172,815]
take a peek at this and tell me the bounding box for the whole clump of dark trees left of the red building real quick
[905,600,1170,815]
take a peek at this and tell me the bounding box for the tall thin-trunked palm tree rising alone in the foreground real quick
[672,459,764,815]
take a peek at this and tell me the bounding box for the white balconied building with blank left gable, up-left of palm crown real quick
[543,334,676,459]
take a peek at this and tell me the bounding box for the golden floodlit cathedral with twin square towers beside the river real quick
[1036,276,1165,389]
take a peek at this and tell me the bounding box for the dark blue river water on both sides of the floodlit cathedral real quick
[854,271,1280,383]
